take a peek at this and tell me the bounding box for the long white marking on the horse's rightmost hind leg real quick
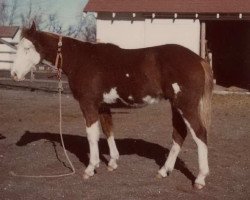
[179,110,209,186]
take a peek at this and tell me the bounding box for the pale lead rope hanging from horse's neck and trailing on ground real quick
[10,36,76,178]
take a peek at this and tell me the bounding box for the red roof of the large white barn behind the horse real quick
[84,0,250,14]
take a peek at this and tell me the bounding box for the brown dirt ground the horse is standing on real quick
[0,89,250,200]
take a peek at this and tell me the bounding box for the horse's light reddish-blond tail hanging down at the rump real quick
[199,61,213,132]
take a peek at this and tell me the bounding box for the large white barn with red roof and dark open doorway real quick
[84,0,250,89]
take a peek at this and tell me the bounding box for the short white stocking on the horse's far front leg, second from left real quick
[108,135,119,171]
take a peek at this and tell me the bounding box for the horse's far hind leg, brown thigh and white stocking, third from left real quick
[158,106,187,177]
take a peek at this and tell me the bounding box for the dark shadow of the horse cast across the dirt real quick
[16,131,195,183]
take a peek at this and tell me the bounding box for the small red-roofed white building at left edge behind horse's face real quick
[0,26,21,70]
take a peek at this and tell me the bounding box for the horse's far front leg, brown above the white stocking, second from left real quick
[99,107,119,171]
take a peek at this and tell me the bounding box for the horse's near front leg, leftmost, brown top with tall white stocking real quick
[80,102,101,179]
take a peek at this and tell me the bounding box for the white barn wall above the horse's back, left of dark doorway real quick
[97,19,200,54]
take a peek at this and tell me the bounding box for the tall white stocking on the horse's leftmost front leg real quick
[84,121,101,178]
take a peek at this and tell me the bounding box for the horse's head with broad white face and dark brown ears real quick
[11,23,41,81]
